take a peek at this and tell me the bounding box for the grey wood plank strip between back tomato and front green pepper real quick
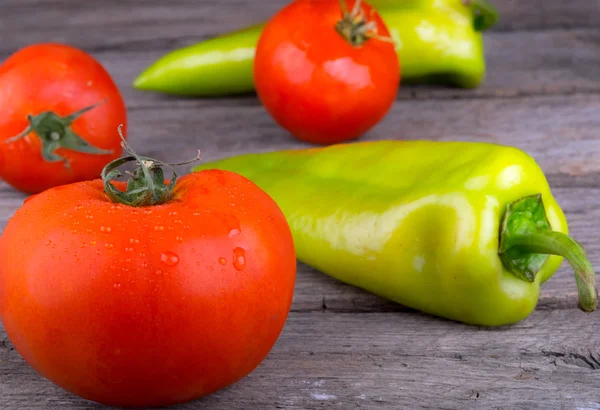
[118,95,600,181]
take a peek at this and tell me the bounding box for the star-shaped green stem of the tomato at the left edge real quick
[4,100,113,170]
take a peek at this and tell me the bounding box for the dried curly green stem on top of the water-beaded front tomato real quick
[102,125,200,207]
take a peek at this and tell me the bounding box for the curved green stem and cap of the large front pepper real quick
[499,195,598,312]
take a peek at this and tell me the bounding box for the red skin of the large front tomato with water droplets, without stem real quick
[0,170,296,407]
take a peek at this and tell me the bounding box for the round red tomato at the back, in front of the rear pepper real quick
[254,0,400,144]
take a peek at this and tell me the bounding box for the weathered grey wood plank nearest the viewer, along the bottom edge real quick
[0,310,600,410]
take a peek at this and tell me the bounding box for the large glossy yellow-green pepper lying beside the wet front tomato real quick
[194,141,597,326]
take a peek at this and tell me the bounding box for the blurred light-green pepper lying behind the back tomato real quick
[133,0,497,96]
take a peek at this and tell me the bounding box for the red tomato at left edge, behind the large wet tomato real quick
[0,44,127,193]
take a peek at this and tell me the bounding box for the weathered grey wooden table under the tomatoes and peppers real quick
[0,0,600,409]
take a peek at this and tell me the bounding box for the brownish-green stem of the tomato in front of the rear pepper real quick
[335,0,394,47]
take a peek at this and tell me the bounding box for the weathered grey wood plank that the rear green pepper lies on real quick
[0,28,600,101]
